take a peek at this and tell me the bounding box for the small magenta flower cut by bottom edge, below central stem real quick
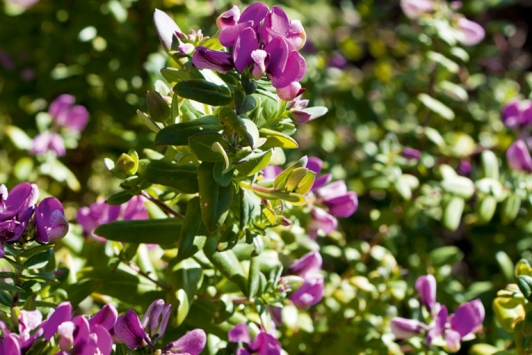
[228,323,282,355]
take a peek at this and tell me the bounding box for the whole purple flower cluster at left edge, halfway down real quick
[0,182,68,257]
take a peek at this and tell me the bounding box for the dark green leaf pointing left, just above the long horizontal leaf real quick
[138,159,199,194]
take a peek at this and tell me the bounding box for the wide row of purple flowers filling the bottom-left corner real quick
[0,299,206,355]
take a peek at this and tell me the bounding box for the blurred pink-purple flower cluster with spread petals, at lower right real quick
[391,275,485,353]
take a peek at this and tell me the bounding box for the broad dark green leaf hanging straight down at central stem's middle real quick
[198,162,234,231]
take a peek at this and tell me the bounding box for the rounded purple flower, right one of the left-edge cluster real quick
[34,197,68,243]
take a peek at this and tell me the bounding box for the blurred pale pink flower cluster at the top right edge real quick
[401,0,486,46]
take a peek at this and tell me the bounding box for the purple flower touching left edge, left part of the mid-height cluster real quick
[0,182,39,245]
